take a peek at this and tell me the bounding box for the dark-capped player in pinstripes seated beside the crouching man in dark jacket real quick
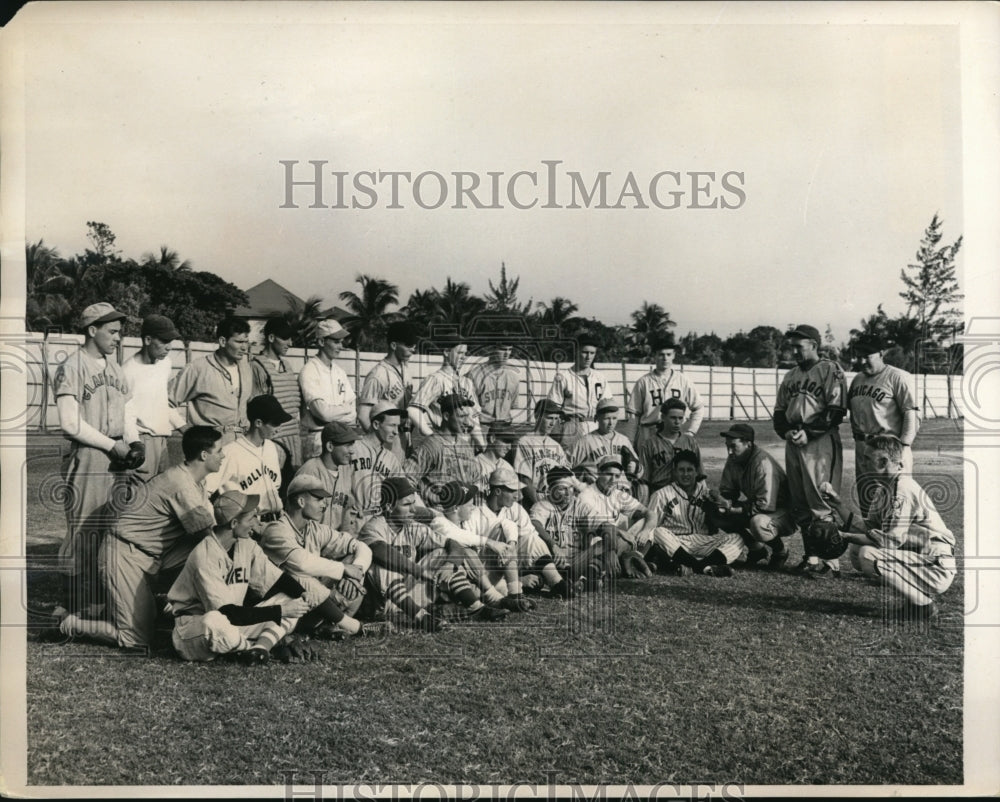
[638,451,743,577]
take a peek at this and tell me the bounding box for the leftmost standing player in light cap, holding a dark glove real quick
[52,303,139,612]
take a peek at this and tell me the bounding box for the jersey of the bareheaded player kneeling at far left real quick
[115,465,215,559]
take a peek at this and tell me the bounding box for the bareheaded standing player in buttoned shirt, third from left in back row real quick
[170,318,253,445]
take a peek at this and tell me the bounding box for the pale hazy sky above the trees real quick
[5,4,963,340]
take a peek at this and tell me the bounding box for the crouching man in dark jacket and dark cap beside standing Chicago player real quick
[709,423,795,568]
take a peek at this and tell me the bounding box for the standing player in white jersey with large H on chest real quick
[625,334,705,453]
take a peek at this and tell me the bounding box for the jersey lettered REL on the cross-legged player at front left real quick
[167,532,281,616]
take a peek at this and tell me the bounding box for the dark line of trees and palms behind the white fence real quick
[25,214,963,373]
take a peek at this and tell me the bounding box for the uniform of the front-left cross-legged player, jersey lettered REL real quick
[167,533,298,661]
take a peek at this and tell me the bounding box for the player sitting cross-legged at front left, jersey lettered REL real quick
[167,490,327,664]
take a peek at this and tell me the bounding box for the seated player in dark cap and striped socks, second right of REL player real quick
[361,476,507,632]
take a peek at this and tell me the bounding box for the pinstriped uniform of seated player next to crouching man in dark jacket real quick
[649,481,743,563]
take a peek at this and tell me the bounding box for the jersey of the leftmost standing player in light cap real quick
[52,348,132,438]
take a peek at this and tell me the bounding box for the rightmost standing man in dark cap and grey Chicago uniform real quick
[847,337,920,516]
